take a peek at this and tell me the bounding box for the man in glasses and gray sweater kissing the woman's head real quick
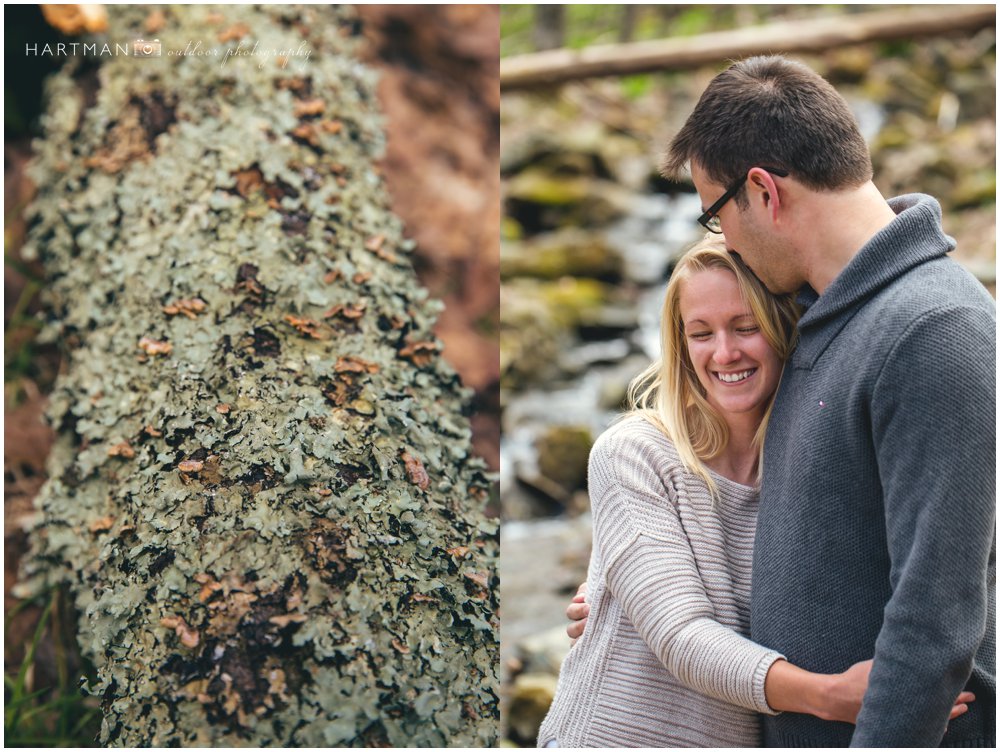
[575,57,996,747]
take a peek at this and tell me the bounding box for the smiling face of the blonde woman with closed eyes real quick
[679,269,782,418]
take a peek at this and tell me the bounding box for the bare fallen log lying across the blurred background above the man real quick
[500,5,996,91]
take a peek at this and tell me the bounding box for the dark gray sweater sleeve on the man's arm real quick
[851,306,996,747]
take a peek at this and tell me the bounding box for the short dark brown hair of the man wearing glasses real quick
[663,56,872,198]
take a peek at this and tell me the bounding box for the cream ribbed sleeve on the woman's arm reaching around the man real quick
[589,424,782,713]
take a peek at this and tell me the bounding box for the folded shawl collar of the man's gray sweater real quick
[799,193,955,329]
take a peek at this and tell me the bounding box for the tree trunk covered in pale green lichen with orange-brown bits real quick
[16,6,498,746]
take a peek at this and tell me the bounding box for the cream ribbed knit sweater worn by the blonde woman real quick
[538,417,782,747]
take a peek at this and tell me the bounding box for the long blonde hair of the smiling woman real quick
[627,235,799,498]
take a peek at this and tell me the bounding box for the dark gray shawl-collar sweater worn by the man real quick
[751,194,996,747]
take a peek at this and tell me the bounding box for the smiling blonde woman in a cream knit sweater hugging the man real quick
[538,235,972,747]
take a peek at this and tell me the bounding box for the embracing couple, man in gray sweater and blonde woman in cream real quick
[538,57,996,747]
